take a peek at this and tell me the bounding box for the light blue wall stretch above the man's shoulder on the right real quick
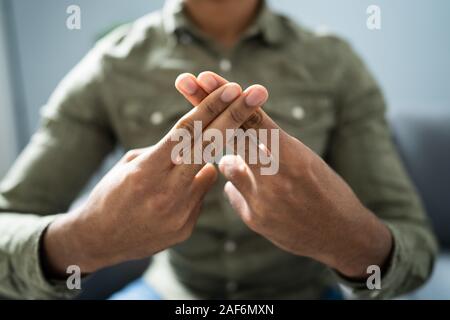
[271,0,450,113]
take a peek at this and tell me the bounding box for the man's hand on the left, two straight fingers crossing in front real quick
[42,75,268,276]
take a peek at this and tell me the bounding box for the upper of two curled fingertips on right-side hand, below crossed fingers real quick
[219,155,257,197]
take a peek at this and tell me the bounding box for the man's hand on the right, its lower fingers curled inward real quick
[174,72,392,279]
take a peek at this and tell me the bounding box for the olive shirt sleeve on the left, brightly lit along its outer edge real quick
[0,28,126,299]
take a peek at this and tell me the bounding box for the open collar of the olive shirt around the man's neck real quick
[162,0,283,45]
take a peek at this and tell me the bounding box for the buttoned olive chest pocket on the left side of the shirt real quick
[119,99,192,149]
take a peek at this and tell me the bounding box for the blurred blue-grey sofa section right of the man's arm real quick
[391,106,450,300]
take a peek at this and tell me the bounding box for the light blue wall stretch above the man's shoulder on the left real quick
[6,0,164,141]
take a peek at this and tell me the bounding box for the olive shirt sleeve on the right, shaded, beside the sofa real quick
[328,38,437,298]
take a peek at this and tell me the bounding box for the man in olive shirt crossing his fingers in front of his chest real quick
[0,0,436,298]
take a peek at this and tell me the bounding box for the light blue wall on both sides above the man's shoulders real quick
[3,0,450,148]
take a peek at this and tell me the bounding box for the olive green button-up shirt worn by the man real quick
[0,1,437,299]
